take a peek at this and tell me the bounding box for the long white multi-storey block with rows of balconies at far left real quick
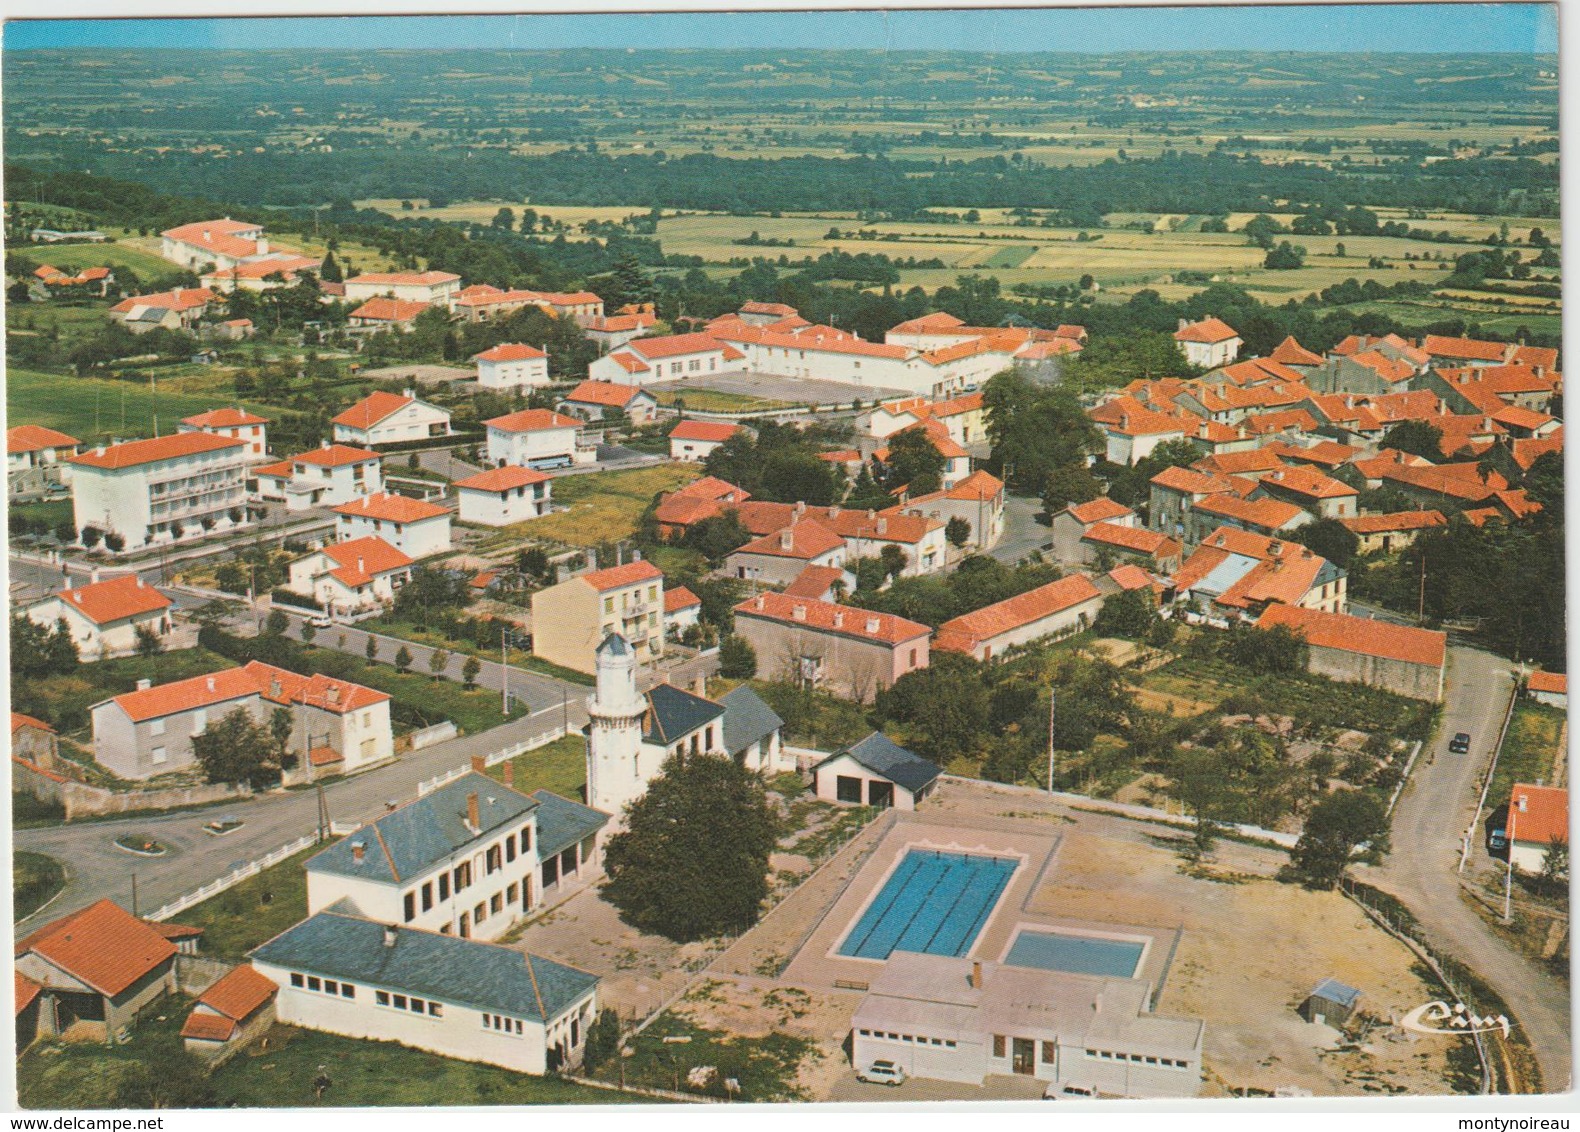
[71,432,248,550]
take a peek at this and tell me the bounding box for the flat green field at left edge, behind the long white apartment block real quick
[6,367,292,441]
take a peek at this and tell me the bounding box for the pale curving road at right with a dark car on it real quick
[1356,648,1572,1092]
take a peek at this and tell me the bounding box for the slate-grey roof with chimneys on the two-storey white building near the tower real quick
[307,772,537,884]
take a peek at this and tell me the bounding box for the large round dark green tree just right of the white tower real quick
[604,754,777,942]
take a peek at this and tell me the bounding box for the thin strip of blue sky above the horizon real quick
[5,0,1558,54]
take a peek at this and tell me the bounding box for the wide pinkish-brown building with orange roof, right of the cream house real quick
[735,591,932,704]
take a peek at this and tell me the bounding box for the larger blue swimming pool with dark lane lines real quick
[839,849,1019,960]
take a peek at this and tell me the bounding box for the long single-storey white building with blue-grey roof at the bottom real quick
[251,911,599,1075]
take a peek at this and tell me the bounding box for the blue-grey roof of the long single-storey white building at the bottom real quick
[253,912,597,1021]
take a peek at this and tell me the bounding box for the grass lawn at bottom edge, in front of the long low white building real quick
[210,1026,653,1108]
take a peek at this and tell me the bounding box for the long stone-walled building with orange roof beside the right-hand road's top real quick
[1256,604,1449,704]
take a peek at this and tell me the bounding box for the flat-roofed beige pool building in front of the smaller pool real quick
[852,952,1206,1097]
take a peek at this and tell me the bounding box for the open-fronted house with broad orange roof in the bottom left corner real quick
[13,900,177,1042]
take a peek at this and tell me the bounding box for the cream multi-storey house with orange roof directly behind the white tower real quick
[532,558,664,674]
